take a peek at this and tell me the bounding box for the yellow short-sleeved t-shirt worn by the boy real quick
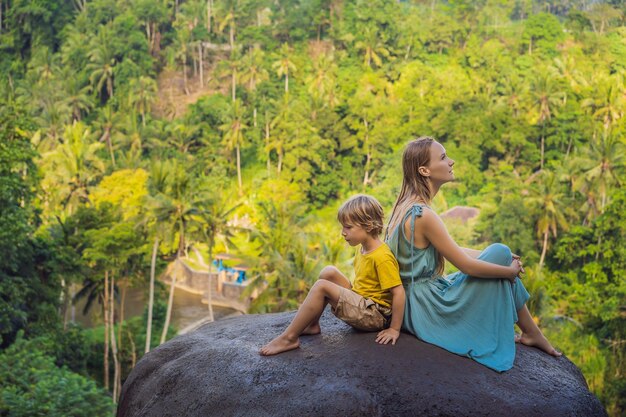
[352,243,402,307]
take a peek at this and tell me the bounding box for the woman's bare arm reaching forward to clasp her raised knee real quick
[414,210,521,282]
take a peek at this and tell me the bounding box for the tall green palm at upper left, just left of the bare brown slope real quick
[87,25,117,99]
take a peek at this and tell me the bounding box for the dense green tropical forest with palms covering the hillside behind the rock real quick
[0,0,626,416]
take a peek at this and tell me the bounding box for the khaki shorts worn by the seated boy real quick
[331,288,391,332]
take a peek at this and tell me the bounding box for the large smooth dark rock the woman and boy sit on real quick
[117,312,606,417]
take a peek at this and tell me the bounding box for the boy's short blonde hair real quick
[337,194,385,237]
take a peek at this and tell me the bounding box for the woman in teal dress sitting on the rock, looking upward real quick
[387,137,561,372]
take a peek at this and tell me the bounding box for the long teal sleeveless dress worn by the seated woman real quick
[387,205,529,372]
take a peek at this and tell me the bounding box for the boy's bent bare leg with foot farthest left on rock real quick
[260,280,341,356]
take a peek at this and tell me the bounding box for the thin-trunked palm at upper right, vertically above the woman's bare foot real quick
[531,71,565,169]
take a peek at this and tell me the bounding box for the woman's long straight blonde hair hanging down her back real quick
[385,136,445,274]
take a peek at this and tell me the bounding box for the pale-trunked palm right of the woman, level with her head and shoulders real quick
[528,170,568,270]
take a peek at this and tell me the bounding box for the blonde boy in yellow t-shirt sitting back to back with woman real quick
[260,194,405,356]
